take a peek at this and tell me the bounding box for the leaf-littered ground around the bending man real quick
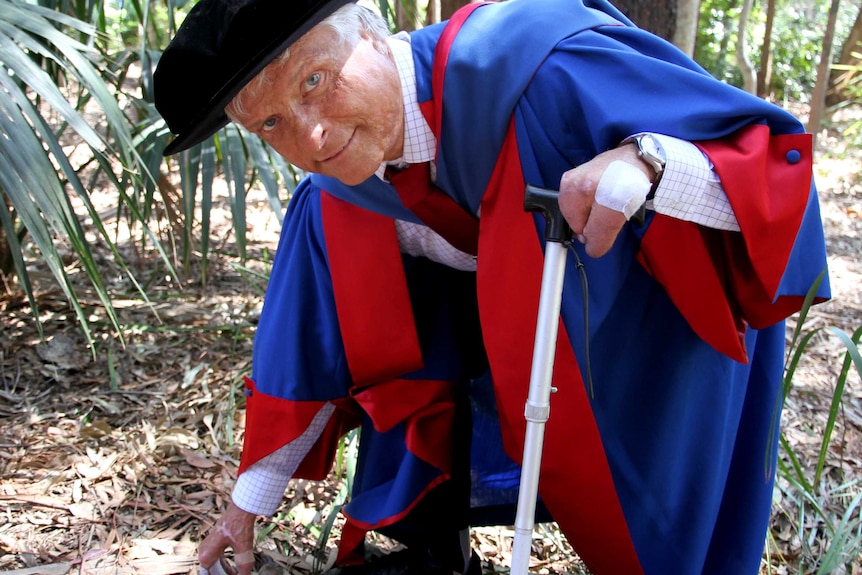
[0,110,862,575]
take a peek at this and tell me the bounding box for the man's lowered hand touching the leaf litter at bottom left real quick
[198,502,257,575]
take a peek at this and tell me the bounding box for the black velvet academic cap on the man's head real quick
[153,0,354,156]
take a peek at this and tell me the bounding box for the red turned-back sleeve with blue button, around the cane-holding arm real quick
[638,125,812,363]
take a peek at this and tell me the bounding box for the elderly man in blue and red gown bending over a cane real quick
[155,0,828,575]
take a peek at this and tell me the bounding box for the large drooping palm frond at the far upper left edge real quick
[0,0,154,344]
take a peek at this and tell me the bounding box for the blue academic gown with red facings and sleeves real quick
[241,0,829,575]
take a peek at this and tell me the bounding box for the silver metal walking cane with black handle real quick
[509,185,572,575]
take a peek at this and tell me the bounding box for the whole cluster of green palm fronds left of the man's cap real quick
[0,0,302,346]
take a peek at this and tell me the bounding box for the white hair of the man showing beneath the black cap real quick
[230,2,389,120]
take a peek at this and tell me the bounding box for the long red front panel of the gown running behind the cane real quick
[478,123,643,575]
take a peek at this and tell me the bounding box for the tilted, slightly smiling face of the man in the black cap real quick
[234,26,404,185]
